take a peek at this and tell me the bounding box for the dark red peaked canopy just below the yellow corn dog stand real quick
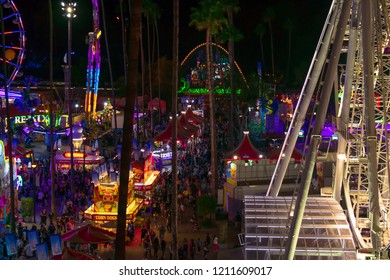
[61,224,115,244]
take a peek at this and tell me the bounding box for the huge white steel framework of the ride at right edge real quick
[267,0,390,259]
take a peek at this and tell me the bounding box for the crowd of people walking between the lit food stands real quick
[0,110,242,259]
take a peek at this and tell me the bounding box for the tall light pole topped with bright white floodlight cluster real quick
[61,1,76,190]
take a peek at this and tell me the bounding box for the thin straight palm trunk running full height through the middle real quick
[171,0,179,260]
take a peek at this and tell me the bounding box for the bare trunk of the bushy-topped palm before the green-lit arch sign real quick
[206,28,218,197]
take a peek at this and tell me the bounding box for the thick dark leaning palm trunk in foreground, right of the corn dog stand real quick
[115,0,142,260]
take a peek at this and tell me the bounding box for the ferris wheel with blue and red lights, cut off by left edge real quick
[0,0,26,86]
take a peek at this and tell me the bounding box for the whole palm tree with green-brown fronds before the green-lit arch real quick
[190,0,227,197]
